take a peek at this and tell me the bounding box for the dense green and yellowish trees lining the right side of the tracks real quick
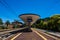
[32,15,60,32]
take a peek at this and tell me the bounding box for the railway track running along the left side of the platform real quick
[0,27,27,40]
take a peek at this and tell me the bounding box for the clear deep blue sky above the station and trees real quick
[0,0,60,21]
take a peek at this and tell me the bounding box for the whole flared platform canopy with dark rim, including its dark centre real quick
[19,14,40,25]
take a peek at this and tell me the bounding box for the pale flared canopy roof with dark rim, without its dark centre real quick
[19,14,40,25]
